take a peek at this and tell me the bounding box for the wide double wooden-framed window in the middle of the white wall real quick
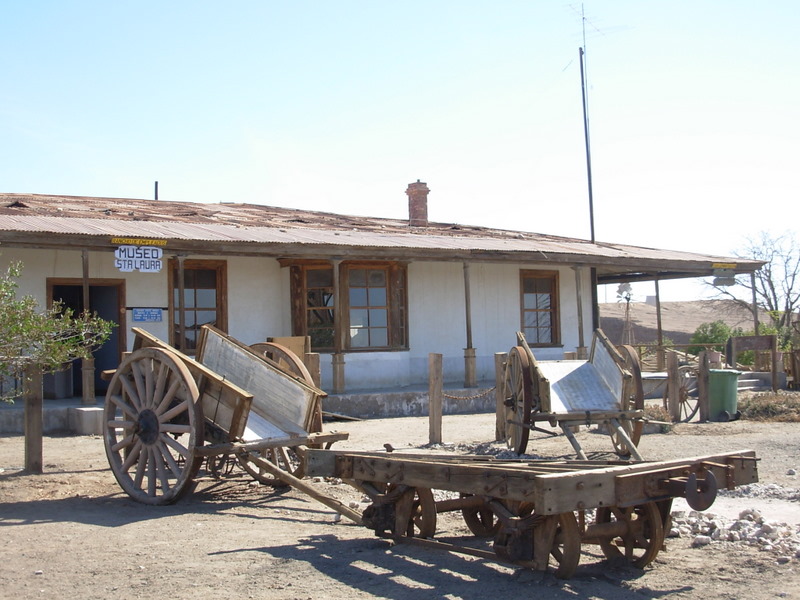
[290,262,408,352]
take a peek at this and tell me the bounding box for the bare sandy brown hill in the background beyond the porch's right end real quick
[600,300,769,345]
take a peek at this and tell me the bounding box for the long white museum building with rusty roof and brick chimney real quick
[0,181,761,406]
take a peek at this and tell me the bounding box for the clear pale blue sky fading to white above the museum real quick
[0,0,800,302]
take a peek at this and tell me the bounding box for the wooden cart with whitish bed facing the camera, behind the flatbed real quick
[503,329,644,460]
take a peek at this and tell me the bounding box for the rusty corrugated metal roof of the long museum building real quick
[0,194,760,270]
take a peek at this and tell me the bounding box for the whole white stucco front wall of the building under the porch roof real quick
[0,248,592,391]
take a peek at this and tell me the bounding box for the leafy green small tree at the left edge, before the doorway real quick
[0,263,114,402]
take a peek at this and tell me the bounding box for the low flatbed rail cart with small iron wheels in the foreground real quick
[305,450,758,578]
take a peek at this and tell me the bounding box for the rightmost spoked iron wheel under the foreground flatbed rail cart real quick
[596,502,664,569]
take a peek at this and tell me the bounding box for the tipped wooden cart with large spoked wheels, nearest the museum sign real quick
[103,326,347,510]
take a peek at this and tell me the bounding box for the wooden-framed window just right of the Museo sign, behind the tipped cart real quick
[169,259,228,354]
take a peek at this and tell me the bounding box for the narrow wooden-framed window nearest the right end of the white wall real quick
[520,271,561,346]
